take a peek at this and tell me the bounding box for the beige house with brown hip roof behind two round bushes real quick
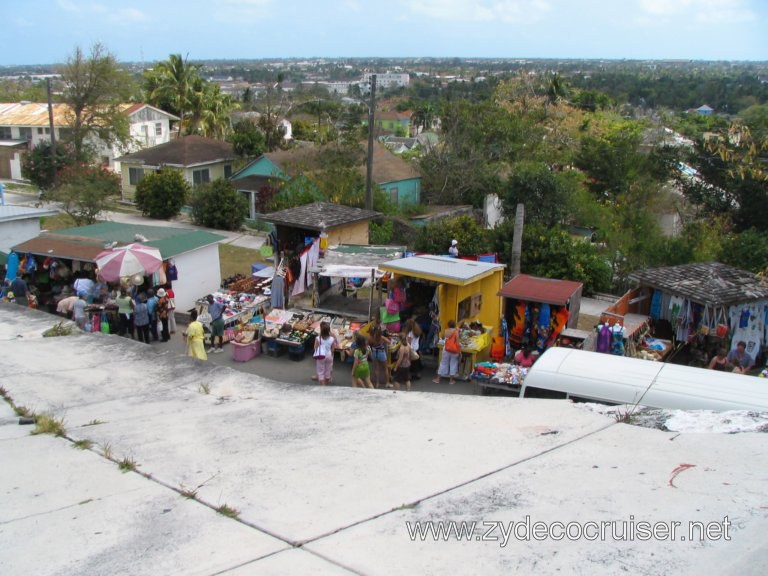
[117,136,237,202]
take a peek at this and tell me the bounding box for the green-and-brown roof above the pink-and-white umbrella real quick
[13,222,224,262]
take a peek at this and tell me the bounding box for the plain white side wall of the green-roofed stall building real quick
[173,244,221,312]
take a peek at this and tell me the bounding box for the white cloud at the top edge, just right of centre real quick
[404,0,552,24]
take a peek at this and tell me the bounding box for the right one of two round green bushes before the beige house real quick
[191,178,248,230]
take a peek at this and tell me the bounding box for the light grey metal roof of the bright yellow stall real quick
[379,256,504,285]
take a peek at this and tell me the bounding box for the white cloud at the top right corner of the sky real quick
[639,0,756,24]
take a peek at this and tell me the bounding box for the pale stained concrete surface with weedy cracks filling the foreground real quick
[0,304,768,576]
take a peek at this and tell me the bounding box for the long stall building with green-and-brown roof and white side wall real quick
[13,222,226,312]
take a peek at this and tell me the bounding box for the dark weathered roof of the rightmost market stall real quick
[629,262,768,306]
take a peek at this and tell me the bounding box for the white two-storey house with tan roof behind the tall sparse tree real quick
[0,101,178,179]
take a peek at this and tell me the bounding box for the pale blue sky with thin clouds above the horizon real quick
[0,0,768,65]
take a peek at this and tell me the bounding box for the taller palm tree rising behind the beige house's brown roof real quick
[147,54,202,137]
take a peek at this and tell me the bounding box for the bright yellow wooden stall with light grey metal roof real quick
[379,255,504,373]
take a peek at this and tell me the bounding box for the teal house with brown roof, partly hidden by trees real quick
[231,142,421,218]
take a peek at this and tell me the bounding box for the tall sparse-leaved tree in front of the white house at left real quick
[61,43,133,161]
